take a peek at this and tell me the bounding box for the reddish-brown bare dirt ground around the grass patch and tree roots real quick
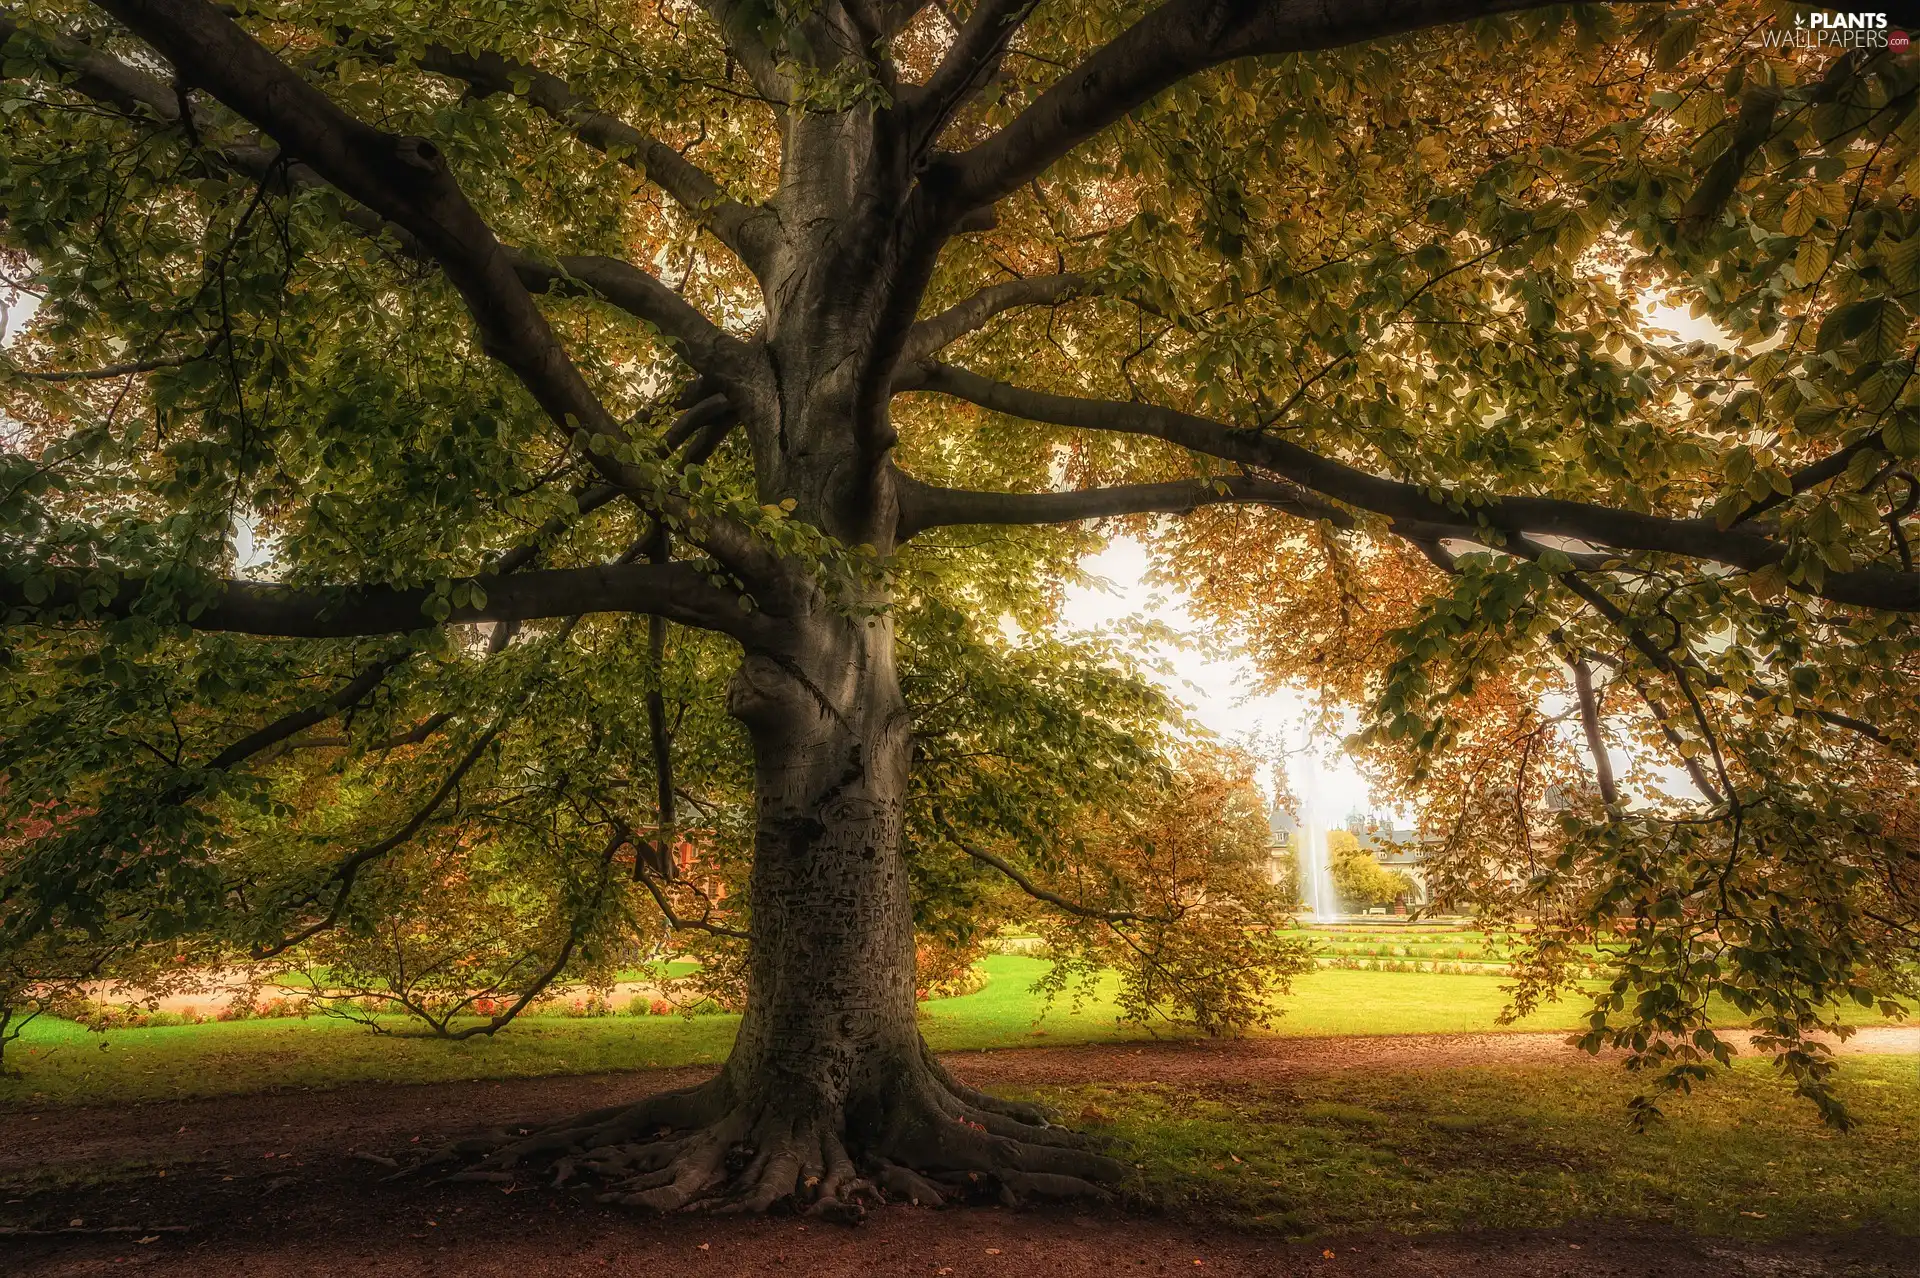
[0,1030,1920,1278]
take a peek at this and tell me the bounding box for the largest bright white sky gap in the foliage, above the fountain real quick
[1064,537,1373,821]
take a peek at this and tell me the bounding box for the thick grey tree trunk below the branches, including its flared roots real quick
[445,612,1121,1219]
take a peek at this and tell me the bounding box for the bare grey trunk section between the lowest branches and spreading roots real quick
[728,618,920,1113]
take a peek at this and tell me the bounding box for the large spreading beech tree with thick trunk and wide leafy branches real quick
[11,0,1920,1209]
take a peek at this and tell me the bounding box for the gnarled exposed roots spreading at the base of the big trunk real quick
[409,1052,1125,1222]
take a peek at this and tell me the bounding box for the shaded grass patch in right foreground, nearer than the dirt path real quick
[1052,1057,1920,1238]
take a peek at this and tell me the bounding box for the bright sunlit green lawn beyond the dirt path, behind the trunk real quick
[0,956,1912,1107]
